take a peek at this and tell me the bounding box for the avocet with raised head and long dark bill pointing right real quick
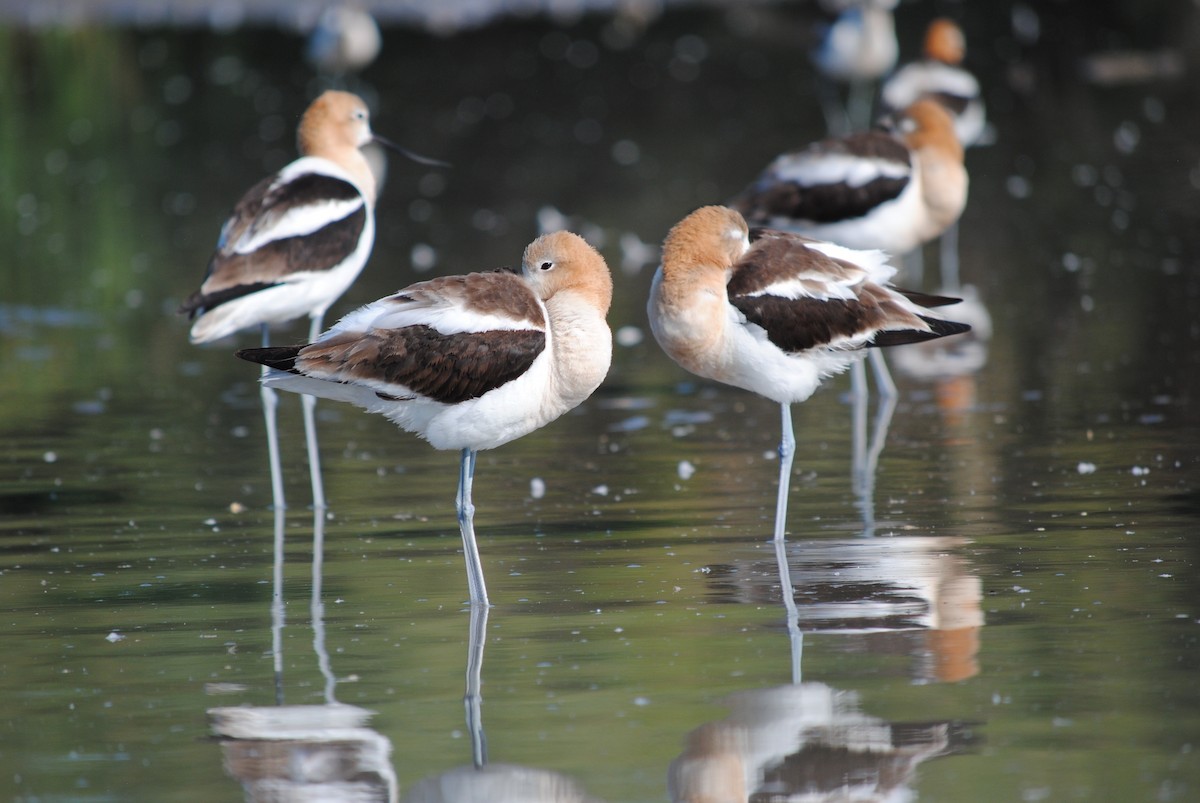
[179,91,444,508]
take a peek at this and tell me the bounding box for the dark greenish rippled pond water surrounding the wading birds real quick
[0,2,1200,801]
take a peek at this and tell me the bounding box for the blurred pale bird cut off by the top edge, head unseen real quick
[812,0,900,136]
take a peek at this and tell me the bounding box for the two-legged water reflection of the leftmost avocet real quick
[208,508,400,803]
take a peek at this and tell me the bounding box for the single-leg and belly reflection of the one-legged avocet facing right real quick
[404,605,609,803]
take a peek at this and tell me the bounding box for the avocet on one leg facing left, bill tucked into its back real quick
[648,206,970,540]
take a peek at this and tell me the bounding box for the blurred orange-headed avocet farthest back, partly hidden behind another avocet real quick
[881,17,988,292]
